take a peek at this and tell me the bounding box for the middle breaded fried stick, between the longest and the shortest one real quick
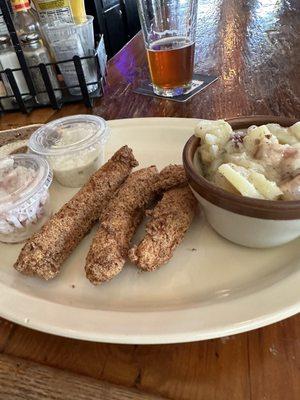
[85,166,159,285]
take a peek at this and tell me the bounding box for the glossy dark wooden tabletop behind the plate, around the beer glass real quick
[48,0,300,119]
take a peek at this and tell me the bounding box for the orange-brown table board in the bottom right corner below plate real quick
[248,314,300,400]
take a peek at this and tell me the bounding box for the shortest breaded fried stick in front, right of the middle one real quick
[128,186,197,271]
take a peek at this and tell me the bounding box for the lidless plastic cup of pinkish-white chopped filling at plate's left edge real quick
[0,154,52,243]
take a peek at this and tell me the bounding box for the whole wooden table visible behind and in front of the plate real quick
[0,0,300,400]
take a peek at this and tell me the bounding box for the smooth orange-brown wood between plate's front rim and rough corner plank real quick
[4,315,300,400]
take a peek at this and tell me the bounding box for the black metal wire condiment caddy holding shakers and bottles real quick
[0,0,106,113]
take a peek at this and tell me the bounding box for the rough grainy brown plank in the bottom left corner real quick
[0,355,166,400]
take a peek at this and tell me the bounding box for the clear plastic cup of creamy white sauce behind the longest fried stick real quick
[28,115,109,187]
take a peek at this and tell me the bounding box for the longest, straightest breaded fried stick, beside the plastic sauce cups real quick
[14,146,138,280]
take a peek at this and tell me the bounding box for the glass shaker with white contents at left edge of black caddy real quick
[0,35,30,103]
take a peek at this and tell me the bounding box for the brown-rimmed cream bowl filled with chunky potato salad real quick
[183,116,300,247]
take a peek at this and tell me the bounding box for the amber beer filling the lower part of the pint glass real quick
[147,37,195,90]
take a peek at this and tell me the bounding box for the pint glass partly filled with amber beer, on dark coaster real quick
[138,0,198,97]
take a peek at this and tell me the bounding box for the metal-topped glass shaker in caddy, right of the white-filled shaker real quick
[20,33,62,104]
